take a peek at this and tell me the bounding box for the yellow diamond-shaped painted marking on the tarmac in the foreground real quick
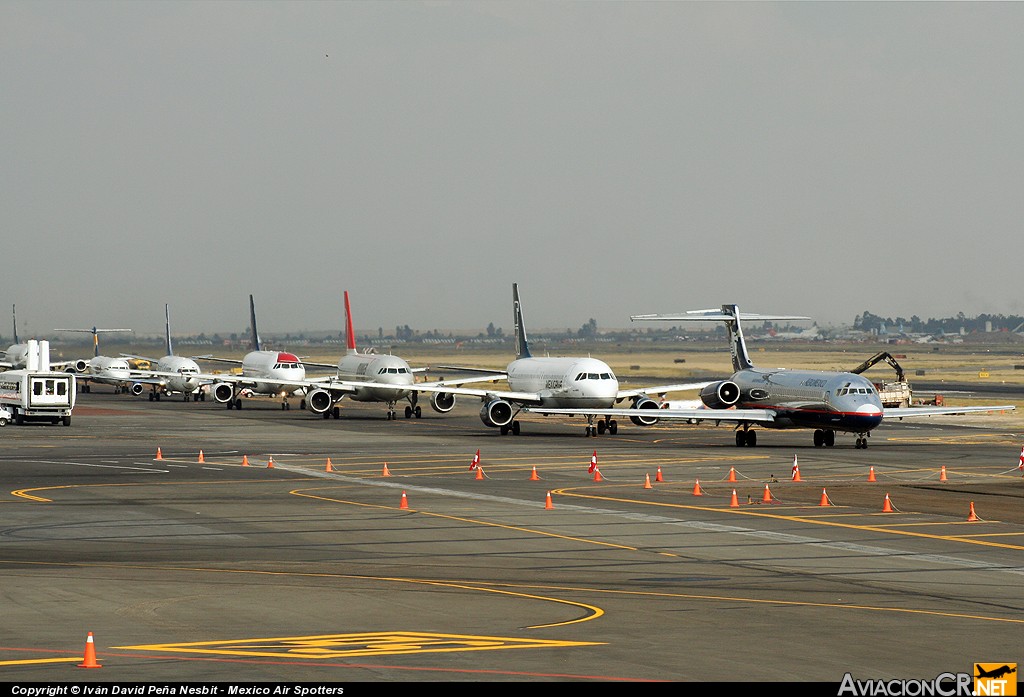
[113,631,601,660]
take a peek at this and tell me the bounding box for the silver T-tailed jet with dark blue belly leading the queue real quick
[530,305,1015,449]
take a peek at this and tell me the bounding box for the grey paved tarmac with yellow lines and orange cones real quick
[0,387,1024,683]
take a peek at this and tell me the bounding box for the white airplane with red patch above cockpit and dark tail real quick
[196,294,306,409]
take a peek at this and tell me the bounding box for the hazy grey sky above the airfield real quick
[0,0,1024,339]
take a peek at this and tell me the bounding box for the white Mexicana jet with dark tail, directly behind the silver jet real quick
[409,284,707,436]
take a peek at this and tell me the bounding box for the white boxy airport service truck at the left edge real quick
[0,340,77,426]
